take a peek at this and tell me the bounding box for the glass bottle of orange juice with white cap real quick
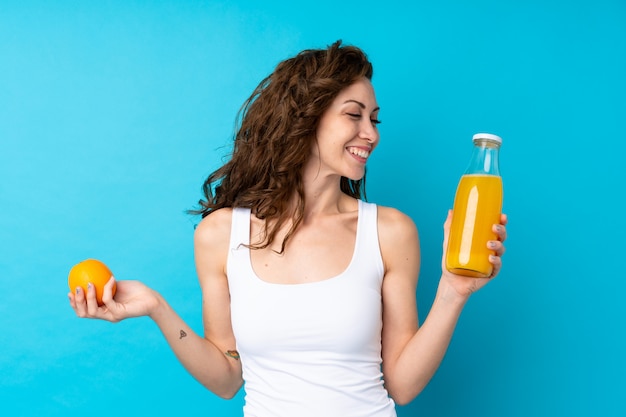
[446,133,502,278]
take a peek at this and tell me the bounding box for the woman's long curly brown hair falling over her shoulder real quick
[191,40,373,253]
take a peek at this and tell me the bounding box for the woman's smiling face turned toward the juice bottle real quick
[309,78,380,180]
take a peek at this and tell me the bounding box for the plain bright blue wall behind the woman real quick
[0,0,626,417]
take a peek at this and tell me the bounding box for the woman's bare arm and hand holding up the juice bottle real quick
[379,208,506,404]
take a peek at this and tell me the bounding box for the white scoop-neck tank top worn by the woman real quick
[227,200,396,417]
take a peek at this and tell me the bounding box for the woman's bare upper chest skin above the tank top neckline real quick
[250,210,358,284]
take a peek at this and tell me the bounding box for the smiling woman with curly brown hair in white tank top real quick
[69,42,506,417]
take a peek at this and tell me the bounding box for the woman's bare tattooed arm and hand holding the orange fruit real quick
[69,210,243,398]
